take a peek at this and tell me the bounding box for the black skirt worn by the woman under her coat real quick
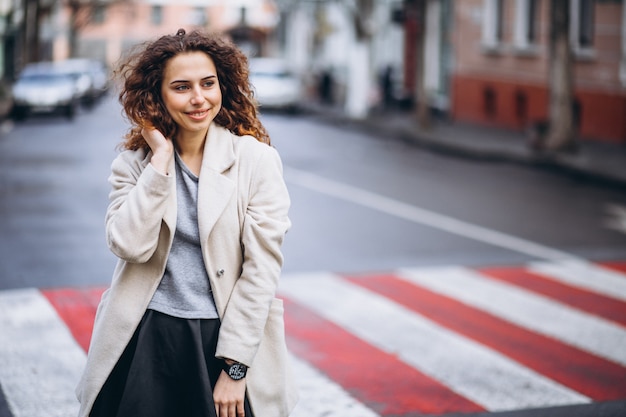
[90,310,253,417]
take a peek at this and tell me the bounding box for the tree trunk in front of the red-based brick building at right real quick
[545,0,575,151]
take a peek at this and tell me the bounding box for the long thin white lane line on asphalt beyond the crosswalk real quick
[285,167,578,261]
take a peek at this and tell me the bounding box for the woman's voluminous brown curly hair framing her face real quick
[116,29,270,150]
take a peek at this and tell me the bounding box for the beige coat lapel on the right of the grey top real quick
[198,123,235,243]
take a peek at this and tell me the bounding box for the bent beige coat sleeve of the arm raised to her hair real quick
[106,151,174,263]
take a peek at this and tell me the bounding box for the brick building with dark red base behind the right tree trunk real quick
[450,0,626,143]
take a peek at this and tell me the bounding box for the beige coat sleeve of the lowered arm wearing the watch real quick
[216,145,291,366]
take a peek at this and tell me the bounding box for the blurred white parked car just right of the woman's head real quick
[249,58,303,111]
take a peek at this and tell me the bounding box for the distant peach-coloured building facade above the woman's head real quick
[50,0,279,65]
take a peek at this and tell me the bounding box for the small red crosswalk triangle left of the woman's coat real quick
[41,288,104,352]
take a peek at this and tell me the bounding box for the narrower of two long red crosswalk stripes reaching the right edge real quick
[478,268,626,326]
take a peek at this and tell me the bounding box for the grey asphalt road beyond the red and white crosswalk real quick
[0,97,626,417]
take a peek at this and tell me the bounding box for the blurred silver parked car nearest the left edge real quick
[12,62,80,119]
